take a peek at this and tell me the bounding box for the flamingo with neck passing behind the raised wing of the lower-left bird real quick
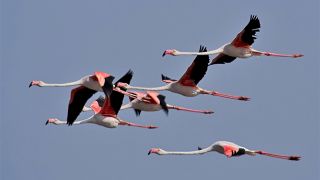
[83,91,213,116]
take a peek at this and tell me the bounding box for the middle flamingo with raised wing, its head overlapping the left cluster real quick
[118,46,249,101]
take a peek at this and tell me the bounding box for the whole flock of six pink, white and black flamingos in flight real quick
[29,15,303,161]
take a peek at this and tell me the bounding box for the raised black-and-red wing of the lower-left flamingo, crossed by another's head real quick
[100,70,133,116]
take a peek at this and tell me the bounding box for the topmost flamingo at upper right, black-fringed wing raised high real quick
[162,15,303,65]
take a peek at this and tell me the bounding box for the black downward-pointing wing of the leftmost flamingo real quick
[67,86,96,125]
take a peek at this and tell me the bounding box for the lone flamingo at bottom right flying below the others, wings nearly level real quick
[148,141,301,161]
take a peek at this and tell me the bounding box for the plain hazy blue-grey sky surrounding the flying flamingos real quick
[0,0,320,180]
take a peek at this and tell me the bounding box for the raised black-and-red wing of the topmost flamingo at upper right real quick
[231,15,261,47]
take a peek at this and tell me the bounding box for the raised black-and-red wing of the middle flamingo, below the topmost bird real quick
[179,46,210,86]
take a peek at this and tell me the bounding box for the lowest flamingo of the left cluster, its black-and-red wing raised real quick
[46,71,157,129]
